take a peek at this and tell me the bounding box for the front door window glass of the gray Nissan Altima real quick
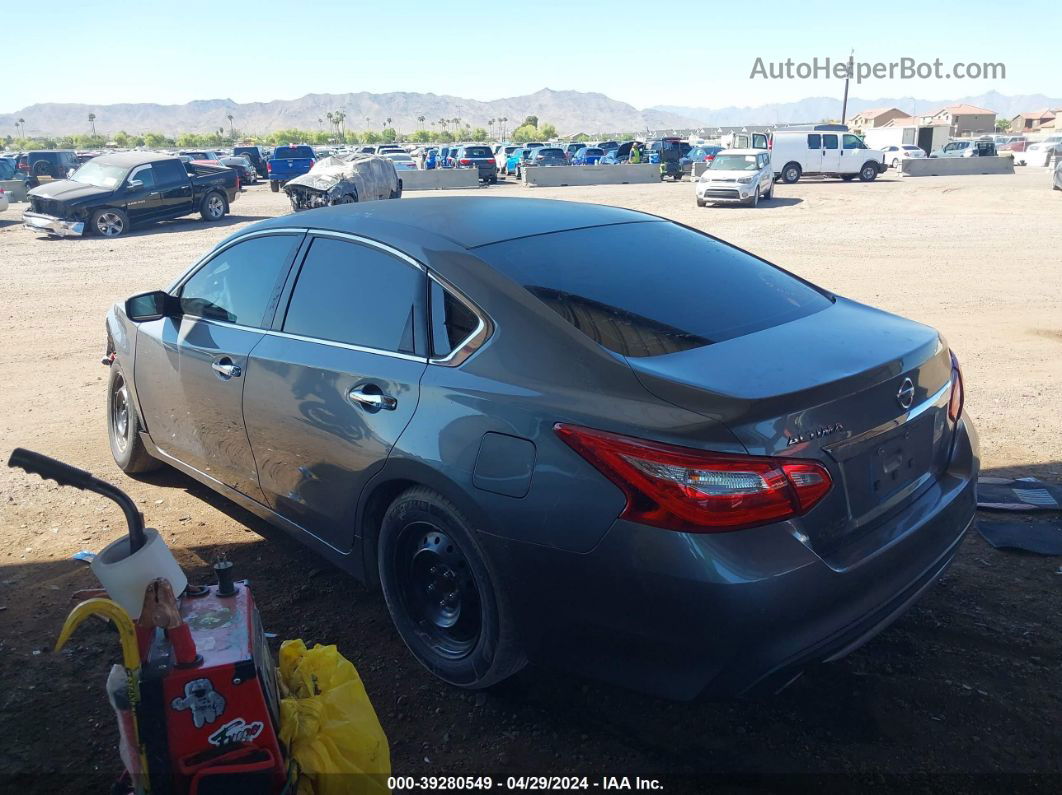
[181,235,298,328]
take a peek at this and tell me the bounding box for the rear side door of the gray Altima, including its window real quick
[244,234,427,551]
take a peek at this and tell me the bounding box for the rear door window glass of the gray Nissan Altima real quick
[284,238,424,353]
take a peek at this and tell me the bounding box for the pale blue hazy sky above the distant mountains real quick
[0,0,1062,113]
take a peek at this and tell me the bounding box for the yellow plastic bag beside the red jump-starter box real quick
[279,640,391,795]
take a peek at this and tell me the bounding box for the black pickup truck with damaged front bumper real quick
[22,152,239,238]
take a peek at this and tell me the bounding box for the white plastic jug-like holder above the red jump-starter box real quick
[92,528,188,621]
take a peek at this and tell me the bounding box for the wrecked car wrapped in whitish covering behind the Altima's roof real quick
[284,154,408,211]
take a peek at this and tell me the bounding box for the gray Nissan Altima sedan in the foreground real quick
[104,197,979,698]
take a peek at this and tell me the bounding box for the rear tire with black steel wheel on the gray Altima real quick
[377,486,527,690]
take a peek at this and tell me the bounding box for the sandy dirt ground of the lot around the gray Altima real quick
[0,169,1062,793]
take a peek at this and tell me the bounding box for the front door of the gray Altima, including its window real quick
[134,229,302,500]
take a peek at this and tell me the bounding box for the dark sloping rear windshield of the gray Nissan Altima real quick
[476,222,830,357]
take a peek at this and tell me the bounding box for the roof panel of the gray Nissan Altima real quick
[245,196,660,249]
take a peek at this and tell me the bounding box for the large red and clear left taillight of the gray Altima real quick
[553,422,833,533]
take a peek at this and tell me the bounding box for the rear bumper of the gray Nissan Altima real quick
[484,411,979,699]
